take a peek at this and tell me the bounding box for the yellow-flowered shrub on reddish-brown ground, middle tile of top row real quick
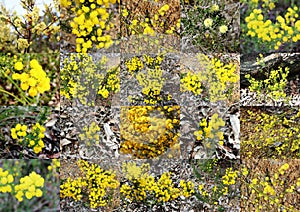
[120,0,180,54]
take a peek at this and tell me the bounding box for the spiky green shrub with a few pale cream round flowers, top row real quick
[181,0,239,53]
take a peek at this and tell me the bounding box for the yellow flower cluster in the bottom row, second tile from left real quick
[60,160,120,208]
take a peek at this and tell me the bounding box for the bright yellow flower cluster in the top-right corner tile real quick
[245,5,300,50]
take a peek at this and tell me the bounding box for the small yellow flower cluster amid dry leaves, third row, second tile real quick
[79,121,100,146]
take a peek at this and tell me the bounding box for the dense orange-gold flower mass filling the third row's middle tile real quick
[120,106,180,158]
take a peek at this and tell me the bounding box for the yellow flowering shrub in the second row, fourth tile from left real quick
[180,54,239,102]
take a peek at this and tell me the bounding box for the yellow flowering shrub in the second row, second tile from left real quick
[60,54,120,106]
